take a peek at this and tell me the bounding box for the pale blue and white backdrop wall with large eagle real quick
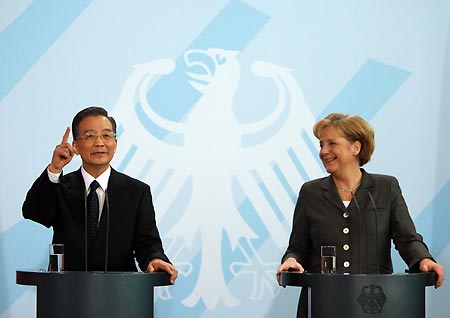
[0,0,450,318]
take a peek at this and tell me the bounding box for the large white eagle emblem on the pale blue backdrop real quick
[112,48,322,309]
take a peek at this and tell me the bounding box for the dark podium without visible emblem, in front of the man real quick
[16,270,170,318]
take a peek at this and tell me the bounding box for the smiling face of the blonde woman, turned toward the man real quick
[319,126,361,174]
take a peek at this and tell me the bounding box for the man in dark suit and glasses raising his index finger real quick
[22,107,178,283]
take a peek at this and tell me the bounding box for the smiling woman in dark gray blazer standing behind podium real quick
[277,113,444,317]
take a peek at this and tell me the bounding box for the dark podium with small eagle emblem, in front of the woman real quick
[281,272,435,318]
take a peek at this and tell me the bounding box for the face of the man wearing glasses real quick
[73,116,117,178]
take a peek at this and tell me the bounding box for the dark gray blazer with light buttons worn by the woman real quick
[282,169,432,274]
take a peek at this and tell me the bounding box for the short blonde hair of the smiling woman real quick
[313,113,375,167]
